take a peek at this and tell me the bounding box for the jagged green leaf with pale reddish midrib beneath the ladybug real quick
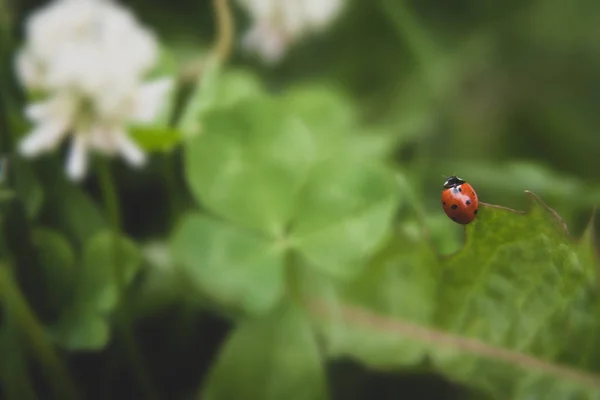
[311,194,600,399]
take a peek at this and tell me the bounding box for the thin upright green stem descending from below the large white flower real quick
[98,160,158,399]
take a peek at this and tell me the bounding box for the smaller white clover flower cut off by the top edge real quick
[238,0,344,64]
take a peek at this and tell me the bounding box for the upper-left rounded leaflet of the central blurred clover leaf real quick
[185,98,314,236]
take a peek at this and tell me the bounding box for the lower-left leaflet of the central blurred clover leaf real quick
[171,214,284,313]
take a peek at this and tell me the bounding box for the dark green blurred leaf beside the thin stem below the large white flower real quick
[50,231,141,350]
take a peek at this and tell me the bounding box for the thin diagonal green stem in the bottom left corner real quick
[0,264,80,399]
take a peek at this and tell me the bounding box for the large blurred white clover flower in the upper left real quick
[16,0,172,180]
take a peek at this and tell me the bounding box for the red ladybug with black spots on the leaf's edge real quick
[442,176,479,225]
